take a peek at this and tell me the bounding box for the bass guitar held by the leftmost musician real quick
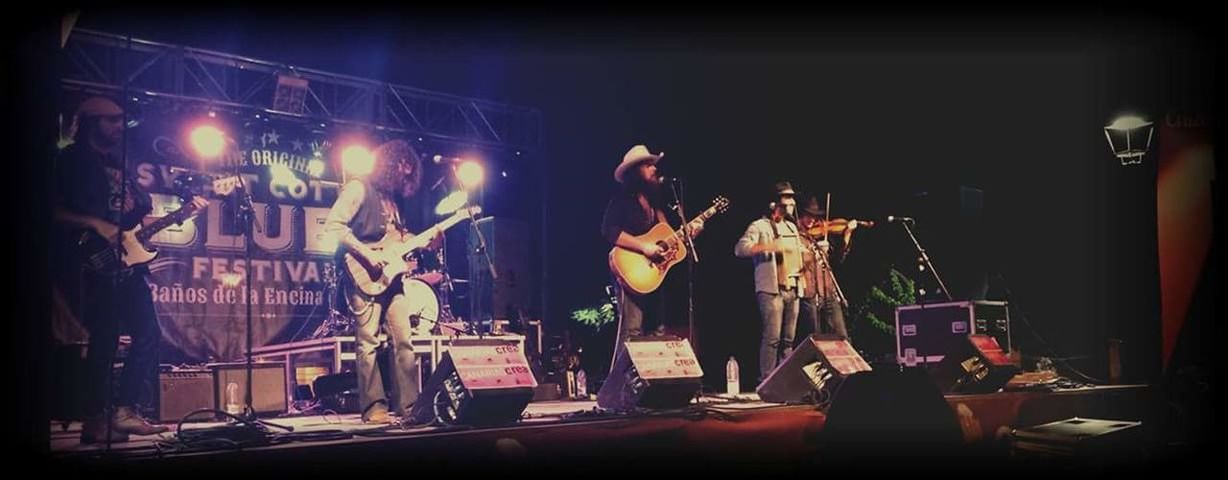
[77,177,242,274]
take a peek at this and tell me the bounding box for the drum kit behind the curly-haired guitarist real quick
[312,248,470,339]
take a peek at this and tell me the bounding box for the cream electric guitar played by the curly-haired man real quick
[343,206,481,296]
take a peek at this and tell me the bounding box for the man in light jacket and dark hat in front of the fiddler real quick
[733,182,807,382]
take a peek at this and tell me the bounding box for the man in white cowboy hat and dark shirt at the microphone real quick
[602,145,704,368]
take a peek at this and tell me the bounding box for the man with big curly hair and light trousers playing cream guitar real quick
[325,140,441,424]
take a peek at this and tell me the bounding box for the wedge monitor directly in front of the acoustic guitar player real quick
[597,335,704,410]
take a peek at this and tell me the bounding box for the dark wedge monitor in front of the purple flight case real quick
[931,335,1019,393]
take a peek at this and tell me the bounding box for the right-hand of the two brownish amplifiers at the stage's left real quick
[209,362,289,415]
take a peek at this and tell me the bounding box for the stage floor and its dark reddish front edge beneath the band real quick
[50,385,1149,473]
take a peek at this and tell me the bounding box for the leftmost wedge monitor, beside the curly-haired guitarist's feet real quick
[410,338,538,425]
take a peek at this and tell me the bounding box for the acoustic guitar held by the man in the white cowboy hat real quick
[609,196,729,295]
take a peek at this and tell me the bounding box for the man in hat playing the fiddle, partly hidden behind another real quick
[797,195,856,338]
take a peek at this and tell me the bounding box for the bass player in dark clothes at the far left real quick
[54,97,209,443]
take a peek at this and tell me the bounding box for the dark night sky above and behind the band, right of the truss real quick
[62,10,1212,387]
